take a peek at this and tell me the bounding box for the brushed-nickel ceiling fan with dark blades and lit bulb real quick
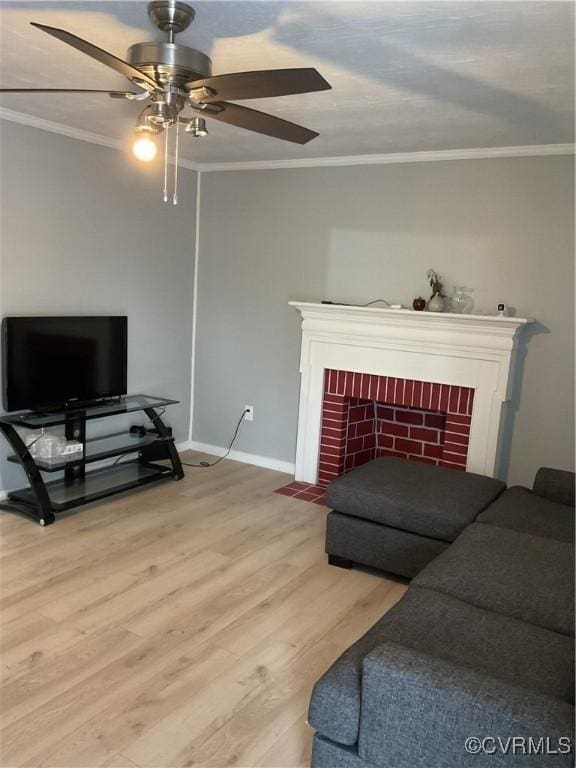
[0,0,331,203]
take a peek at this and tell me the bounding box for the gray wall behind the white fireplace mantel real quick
[193,157,574,483]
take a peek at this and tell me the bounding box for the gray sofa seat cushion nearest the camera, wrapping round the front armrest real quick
[309,586,574,744]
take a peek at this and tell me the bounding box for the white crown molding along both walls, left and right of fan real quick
[0,107,575,173]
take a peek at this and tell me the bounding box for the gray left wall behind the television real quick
[0,121,196,489]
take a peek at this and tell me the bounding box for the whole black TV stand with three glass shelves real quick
[0,395,184,526]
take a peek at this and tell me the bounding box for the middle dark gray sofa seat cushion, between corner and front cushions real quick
[413,523,574,634]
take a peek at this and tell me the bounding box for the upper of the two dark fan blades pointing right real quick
[185,68,332,102]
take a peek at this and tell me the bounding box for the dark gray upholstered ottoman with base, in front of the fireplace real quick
[326,457,506,578]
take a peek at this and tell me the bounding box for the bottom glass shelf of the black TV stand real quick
[9,461,172,512]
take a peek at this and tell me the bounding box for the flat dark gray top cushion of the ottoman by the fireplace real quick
[326,457,505,541]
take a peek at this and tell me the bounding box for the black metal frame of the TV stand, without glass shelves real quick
[0,400,184,526]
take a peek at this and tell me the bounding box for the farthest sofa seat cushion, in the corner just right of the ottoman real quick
[477,486,574,542]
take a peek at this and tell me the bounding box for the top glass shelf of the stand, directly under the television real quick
[0,395,179,429]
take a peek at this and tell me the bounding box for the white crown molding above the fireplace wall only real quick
[197,144,575,173]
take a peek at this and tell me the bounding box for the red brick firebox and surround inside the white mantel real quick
[319,370,474,485]
